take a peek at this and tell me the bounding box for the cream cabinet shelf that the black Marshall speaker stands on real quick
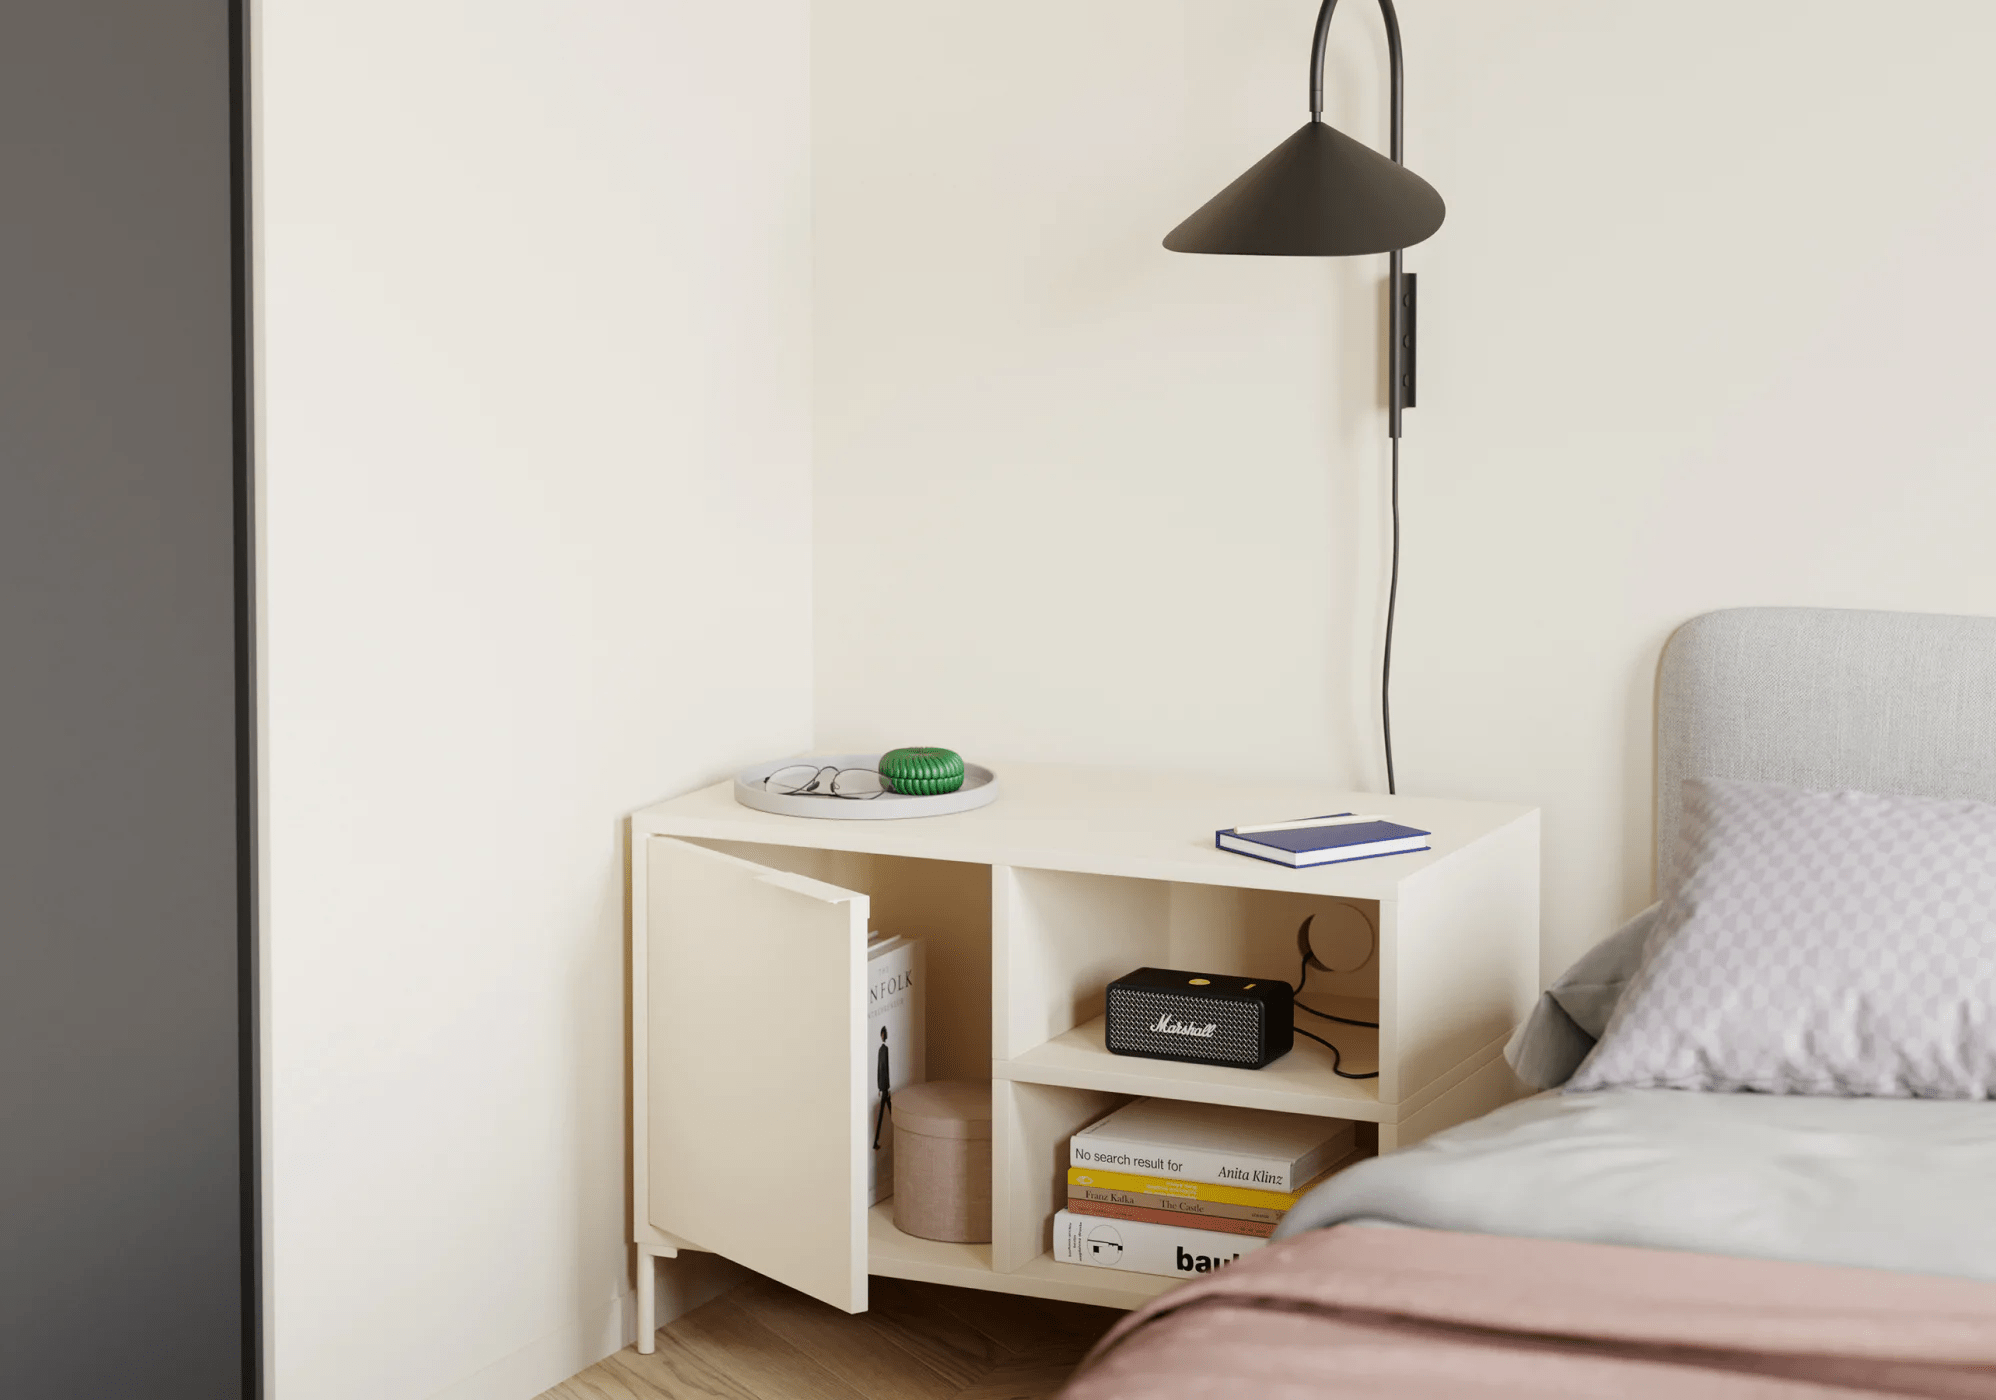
[992,1017,1379,1122]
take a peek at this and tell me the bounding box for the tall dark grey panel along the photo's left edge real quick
[0,0,251,1400]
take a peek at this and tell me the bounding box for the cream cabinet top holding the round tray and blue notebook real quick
[631,763,1537,899]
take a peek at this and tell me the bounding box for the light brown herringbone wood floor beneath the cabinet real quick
[541,1278,1122,1400]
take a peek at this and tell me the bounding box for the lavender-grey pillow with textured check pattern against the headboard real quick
[1567,779,1996,1098]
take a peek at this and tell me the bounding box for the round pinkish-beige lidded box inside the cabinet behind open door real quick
[894,1078,992,1244]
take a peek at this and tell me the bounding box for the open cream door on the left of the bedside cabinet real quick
[645,837,866,1312]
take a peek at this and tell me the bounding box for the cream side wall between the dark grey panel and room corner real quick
[257,0,810,1400]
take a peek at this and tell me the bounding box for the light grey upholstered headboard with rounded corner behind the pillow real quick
[1657,607,1996,893]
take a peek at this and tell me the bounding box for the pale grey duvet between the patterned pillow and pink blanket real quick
[1275,1088,1996,1280]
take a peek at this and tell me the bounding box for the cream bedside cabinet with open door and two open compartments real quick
[631,765,1539,1348]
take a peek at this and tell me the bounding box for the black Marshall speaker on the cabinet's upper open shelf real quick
[1104,967,1295,1068]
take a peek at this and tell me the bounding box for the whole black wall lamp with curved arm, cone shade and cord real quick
[1164,0,1447,793]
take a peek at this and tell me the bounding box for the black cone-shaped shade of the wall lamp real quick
[1164,122,1447,258]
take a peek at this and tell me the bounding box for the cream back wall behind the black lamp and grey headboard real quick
[814,0,1996,971]
